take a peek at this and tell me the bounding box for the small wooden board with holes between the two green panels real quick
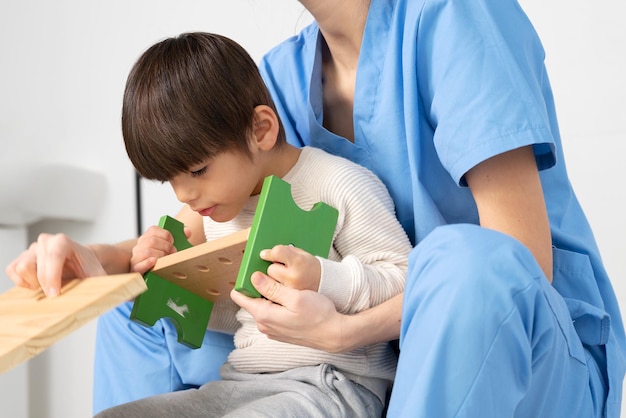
[152,228,250,302]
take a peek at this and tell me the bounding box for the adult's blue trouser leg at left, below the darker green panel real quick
[93,302,234,415]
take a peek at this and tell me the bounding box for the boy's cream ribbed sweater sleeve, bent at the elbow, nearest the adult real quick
[318,159,412,313]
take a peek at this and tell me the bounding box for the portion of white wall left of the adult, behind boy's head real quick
[0,0,306,418]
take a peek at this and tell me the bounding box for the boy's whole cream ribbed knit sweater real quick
[204,147,411,396]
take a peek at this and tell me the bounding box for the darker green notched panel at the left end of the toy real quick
[130,215,213,348]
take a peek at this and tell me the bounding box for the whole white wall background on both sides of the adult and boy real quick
[0,0,626,418]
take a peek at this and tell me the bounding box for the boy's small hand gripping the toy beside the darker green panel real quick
[130,225,183,274]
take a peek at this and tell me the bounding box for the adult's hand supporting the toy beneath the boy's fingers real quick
[231,272,350,353]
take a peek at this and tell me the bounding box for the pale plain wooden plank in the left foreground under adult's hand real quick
[0,273,146,373]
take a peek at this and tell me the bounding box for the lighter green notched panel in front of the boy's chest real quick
[235,176,338,297]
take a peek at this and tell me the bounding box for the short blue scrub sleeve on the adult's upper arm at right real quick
[416,0,556,185]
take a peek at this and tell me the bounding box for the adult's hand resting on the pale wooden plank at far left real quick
[6,234,106,297]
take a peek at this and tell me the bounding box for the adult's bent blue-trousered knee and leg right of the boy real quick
[388,225,607,418]
